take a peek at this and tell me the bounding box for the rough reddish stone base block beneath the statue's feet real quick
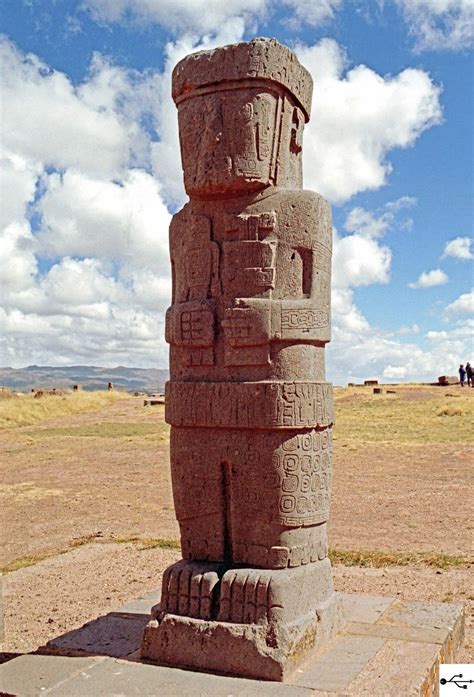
[141,594,344,681]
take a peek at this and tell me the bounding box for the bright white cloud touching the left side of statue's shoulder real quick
[38,170,171,274]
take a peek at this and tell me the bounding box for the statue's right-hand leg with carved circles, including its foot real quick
[219,431,333,622]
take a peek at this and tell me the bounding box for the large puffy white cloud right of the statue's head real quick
[296,39,441,203]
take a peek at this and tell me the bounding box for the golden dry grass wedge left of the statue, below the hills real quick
[0,391,130,428]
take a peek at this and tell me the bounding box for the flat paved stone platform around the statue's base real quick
[0,593,464,697]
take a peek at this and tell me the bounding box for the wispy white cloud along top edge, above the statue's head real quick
[82,0,268,34]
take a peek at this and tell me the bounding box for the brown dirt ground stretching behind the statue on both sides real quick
[0,388,474,658]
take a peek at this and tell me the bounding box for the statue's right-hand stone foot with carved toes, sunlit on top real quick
[217,569,271,624]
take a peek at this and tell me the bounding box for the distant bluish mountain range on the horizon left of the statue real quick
[0,365,169,393]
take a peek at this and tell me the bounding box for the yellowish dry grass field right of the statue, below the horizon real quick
[335,386,474,447]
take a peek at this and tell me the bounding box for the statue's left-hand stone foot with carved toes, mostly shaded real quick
[157,560,223,620]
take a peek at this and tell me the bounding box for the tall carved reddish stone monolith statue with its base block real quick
[142,39,339,680]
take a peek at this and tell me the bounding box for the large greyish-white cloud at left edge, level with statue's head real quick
[0,39,141,176]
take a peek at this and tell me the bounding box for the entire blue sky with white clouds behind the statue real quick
[0,0,474,384]
